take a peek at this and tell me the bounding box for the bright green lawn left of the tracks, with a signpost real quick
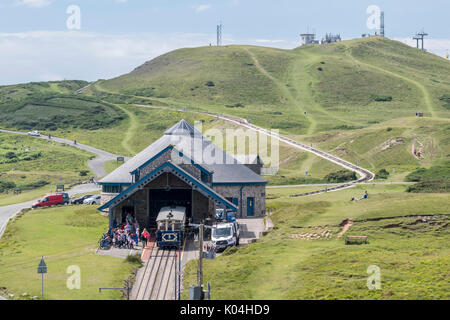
[0,206,136,300]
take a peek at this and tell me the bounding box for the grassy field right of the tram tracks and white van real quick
[183,185,450,300]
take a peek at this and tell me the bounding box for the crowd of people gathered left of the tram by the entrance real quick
[100,214,150,249]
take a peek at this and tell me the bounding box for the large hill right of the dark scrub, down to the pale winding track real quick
[91,37,450,180]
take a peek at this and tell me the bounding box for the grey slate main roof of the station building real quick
[100,120,267,184]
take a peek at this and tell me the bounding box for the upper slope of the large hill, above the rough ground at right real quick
[95,37,450,134]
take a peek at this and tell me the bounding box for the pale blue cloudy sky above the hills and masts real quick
[0,0,450,85]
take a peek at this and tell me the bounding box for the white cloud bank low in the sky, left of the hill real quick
[0,31,215,85]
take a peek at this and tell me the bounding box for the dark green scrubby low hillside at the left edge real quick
[0,81,125,131]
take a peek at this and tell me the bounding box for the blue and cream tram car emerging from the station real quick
[156,206,186,248]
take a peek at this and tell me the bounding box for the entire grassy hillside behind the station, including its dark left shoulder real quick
[0,37,450,184]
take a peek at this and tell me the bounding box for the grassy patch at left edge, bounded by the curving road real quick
[0,133,93,205]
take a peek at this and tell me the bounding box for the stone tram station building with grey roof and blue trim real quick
[99,120,267,228]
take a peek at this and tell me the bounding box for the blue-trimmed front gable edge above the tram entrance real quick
[98,161,238,212]
